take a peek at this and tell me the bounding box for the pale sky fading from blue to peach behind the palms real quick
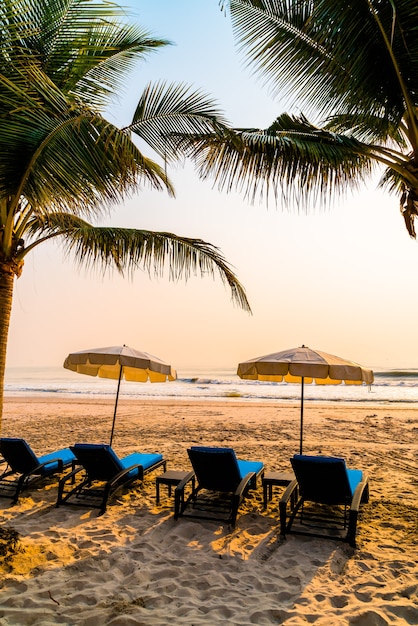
[7,0,418,373]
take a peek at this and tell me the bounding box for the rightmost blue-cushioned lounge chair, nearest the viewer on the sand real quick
[279,454,369,547]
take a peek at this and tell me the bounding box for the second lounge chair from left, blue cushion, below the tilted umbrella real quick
[57,443,167,515]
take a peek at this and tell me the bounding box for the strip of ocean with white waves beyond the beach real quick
[5,367,418,404]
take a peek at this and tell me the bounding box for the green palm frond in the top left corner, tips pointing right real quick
[0,0,170,108]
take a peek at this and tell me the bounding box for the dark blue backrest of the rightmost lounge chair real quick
[290,454,352,504]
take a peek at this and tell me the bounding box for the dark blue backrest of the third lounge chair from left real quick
[187,446,241,492]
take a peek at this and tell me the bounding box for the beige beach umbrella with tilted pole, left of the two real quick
[64,345,177,445]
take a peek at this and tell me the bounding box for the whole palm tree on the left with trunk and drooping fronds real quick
[0,0,249,419]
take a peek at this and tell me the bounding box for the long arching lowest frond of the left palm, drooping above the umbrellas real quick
[22,213,251,312]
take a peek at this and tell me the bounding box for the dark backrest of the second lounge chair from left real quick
[70,443,124,481]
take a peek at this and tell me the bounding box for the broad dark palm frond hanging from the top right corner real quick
[229,0,418,120]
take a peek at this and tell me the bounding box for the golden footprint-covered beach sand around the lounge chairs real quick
[0,398,418,626]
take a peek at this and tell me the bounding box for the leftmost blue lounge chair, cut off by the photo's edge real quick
[0,437,75,504]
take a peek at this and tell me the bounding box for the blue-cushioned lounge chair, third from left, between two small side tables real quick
[174,446,264,527]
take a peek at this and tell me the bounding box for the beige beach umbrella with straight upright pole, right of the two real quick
[237,346,374,454]
